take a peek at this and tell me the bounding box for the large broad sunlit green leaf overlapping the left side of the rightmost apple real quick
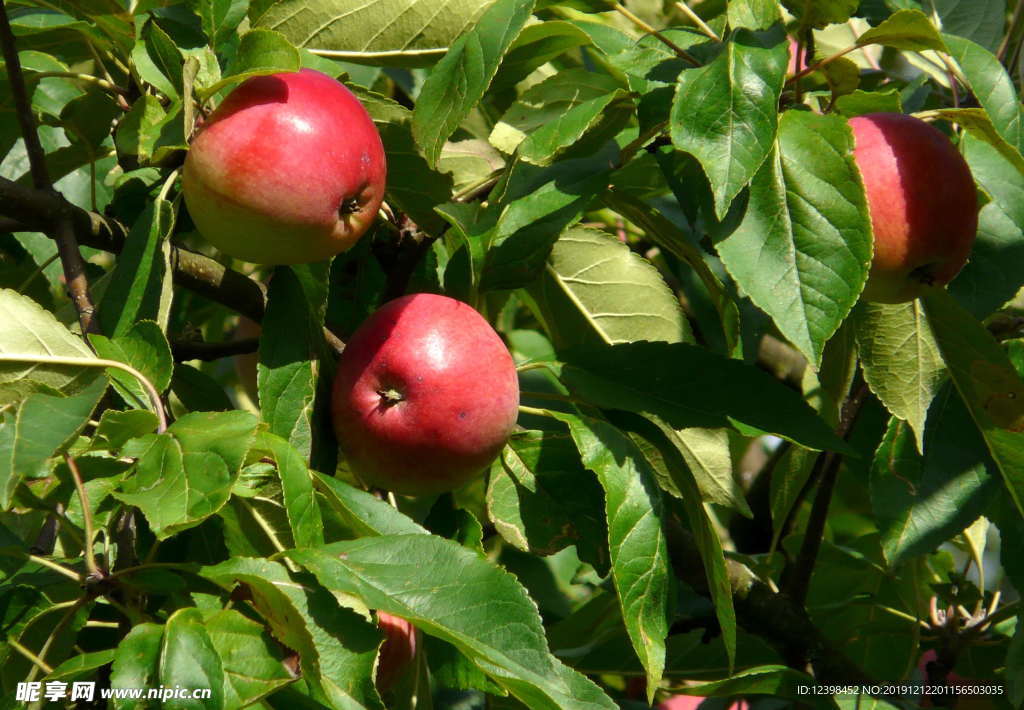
[716,111,871,366]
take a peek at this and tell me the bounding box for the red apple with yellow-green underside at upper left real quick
[181,69,387,264]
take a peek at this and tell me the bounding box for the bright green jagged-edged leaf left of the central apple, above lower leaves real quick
[114,411,256,539]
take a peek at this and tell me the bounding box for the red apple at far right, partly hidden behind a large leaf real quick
[850,114,978,303]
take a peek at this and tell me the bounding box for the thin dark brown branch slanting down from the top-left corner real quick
[0,0,99,333]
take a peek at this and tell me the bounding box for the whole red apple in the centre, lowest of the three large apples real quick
[333,293,519,495]
